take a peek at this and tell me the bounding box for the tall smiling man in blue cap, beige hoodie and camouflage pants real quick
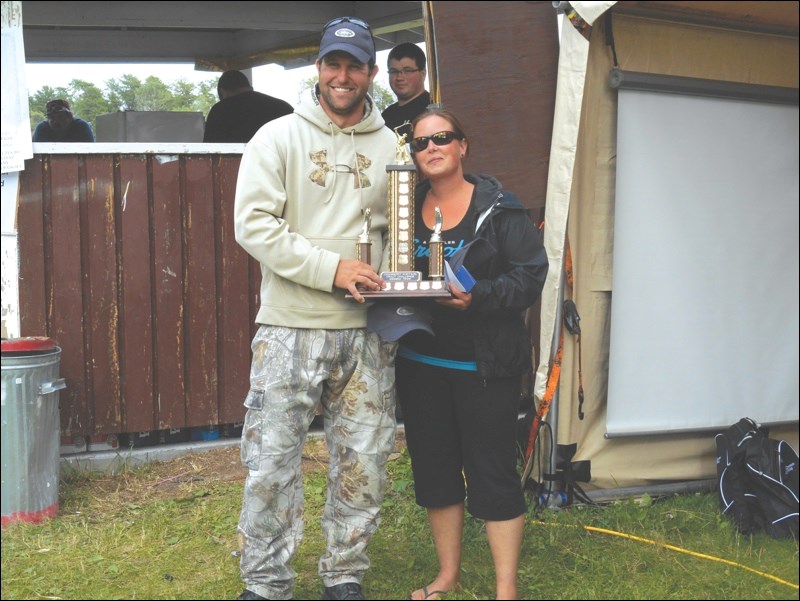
[234,17,397,599]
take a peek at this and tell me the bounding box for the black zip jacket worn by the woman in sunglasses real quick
[416,174,548,378]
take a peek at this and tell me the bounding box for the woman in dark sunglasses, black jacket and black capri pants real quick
[396,108,548,599]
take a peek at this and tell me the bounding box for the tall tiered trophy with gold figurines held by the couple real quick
[356,131,452,298]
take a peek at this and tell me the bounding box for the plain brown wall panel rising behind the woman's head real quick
[433,2,558,212]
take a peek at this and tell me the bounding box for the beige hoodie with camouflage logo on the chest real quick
[234,89,397,329]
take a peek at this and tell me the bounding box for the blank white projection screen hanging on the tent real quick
[607,84,800,436]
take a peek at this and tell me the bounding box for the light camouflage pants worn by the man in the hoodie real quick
[239,326,396,599]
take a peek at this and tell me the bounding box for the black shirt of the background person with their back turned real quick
[203,91,294,142]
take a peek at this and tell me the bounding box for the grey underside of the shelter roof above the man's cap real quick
[22,2,424,71]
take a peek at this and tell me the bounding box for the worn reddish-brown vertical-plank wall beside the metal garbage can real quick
[18,153,260,436]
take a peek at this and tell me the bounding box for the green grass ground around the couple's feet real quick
[2,440,798,599]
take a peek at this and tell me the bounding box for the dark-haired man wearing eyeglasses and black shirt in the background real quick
[381,42,431,140]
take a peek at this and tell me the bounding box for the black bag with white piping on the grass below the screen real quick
[714,417,798,539]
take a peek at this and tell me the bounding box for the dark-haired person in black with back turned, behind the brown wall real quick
[203,71,294,142]
